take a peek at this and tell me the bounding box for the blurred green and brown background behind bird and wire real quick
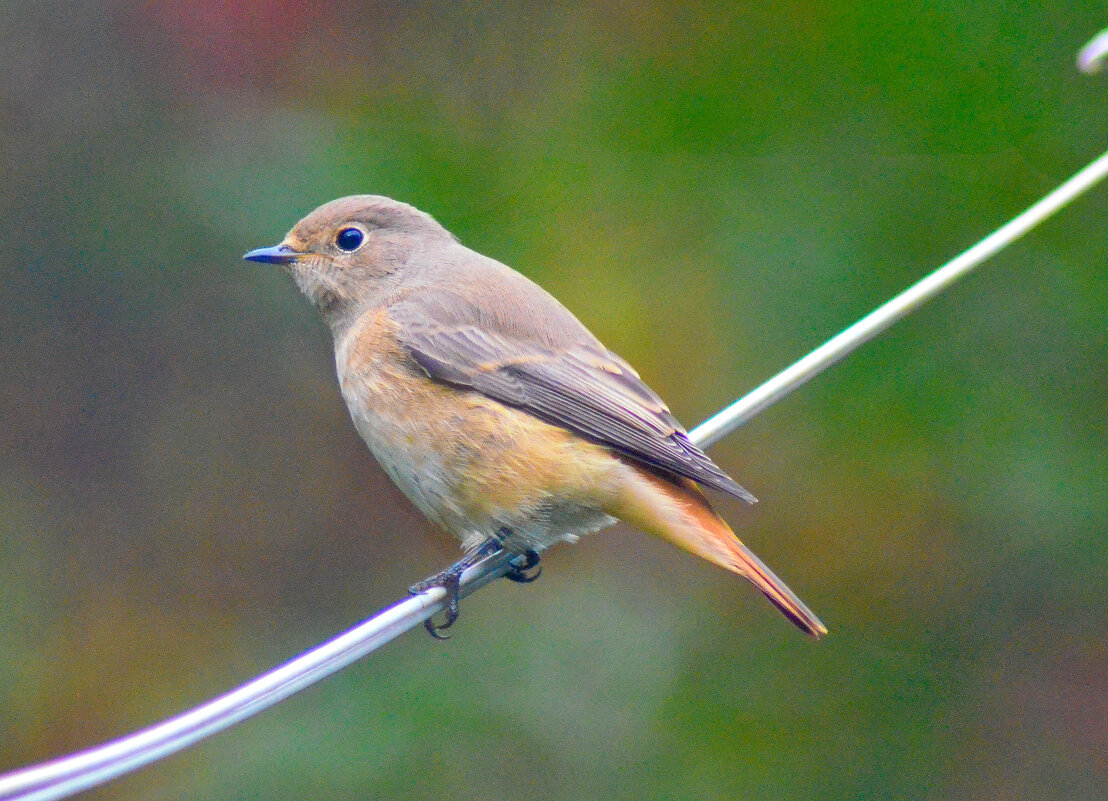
[0,0,1108,800]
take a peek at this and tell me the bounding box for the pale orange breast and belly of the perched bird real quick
[336,305,619,546]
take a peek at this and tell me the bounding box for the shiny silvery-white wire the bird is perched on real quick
[0,146,1108,801]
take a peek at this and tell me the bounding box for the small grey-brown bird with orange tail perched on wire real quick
[244,195,827,637]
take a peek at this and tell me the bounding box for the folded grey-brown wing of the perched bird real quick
[389,300,756,503]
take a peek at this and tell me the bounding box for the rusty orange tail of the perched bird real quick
[606,463,828,637]
